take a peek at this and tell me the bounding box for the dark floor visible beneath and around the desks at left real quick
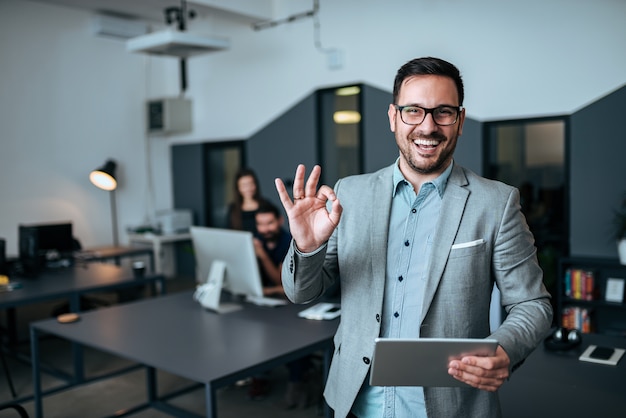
[0,280,323,418]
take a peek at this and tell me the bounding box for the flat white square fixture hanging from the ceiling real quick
[126,30,230,58]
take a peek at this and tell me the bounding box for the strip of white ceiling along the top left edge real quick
[29,0,272,23]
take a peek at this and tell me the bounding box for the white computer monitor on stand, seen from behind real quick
[190,226,263,313]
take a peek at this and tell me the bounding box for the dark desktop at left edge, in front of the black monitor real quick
[0,263,162,309]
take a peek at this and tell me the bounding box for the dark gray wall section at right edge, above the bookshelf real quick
[569,86,626,258]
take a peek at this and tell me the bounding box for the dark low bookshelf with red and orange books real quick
[556,257,626,337]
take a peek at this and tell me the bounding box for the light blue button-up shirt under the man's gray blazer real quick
[352,158,452,418]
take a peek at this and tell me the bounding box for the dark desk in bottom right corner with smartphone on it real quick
[500,334,626,418]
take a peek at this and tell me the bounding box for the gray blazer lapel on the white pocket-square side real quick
[421,164,469,321]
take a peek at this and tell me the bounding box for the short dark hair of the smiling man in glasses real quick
[393,57,465,106]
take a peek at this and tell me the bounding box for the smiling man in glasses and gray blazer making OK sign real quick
[276,57,552,418]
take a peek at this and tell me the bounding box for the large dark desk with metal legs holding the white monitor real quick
[31,292,339,417]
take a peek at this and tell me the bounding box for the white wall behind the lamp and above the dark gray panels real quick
[0,0,626,254]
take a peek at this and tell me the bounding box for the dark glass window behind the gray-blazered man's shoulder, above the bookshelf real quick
[485,117,569,300]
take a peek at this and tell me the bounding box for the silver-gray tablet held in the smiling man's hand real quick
[370,338,498,387]
